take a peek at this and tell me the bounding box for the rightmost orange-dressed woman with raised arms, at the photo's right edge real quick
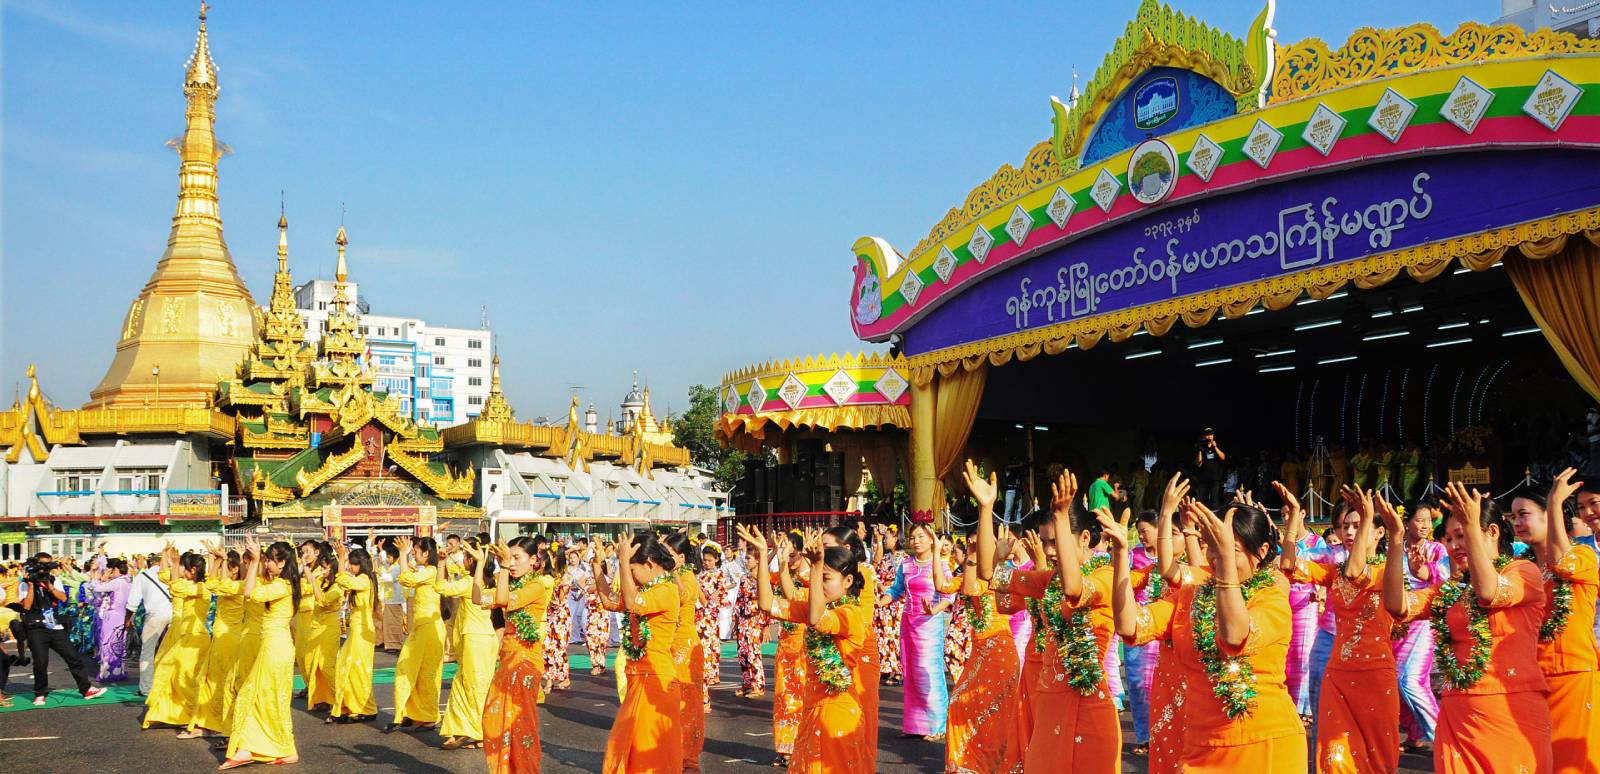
[1510,469,1600,774]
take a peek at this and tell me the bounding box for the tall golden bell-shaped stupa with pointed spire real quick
[85,3,259,408]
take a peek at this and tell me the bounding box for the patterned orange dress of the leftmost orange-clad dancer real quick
[480,573,555,774]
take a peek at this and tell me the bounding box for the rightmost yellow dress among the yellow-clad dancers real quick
[438,558,499,750]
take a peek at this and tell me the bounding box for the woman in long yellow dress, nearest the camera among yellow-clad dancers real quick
[218,536,301,771]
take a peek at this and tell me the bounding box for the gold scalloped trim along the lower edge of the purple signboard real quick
[907,209,1600,379]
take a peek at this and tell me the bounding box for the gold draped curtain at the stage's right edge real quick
[1506,232,1600,400]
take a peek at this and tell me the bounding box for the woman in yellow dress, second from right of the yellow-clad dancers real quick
[384,537,445,734]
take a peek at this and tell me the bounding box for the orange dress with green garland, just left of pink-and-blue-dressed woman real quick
[771,596,878,774]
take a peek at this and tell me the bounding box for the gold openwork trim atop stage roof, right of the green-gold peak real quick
[1267,21,1600,106]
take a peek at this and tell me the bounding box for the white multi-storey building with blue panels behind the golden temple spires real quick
[294,280,494,427]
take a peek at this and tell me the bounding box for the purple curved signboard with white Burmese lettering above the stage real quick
[906,150,1600,355]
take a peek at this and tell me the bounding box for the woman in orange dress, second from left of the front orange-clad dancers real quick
[594,531,681,774]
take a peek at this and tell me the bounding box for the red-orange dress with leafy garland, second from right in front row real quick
[1403,557,1554,774]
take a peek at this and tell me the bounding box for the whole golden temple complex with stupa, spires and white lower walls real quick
[0,5,725,557]
